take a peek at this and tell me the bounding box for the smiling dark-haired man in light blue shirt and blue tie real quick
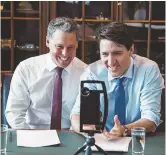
[71,22,164,139]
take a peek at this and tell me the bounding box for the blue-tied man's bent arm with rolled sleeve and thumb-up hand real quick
[106,64,164,137]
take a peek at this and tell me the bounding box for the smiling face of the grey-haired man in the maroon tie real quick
[46,30,78,68]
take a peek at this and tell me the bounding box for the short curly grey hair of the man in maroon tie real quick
[47,17,79,41]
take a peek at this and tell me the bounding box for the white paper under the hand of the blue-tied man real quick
[92,134,131,152]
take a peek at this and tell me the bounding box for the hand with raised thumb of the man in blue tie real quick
[104,115,124,139]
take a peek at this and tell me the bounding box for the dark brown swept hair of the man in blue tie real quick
[97,22,133,50]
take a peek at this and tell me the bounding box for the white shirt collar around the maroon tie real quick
[46,53,73,74]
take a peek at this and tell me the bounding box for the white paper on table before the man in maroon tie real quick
[17,130,60,147]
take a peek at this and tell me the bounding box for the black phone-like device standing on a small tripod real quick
[74,80,108,155]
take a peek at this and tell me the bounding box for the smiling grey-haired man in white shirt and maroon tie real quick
[6,17,86,129]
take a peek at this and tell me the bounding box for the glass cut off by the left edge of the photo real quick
[1,124,8,153]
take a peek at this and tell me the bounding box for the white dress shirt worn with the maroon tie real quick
[5,53,87,129]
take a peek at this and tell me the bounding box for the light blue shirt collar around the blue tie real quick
[108,56,134,81]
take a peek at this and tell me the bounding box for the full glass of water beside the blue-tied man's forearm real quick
[131,127,146,155]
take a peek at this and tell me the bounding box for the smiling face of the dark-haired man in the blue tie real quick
[100,39,132,77]
